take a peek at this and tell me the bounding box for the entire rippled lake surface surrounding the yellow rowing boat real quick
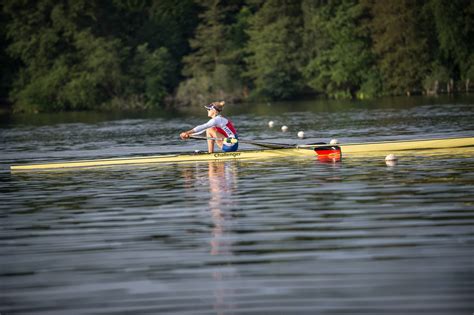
[0,98,474,315]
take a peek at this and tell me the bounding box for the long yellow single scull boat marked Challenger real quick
[10,137,474,171]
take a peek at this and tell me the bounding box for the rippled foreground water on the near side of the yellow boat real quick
[0,153,474,314]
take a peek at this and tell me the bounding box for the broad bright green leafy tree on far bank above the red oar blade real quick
[304,0,380,98]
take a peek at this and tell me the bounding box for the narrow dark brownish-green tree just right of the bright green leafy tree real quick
[362,0,430,94]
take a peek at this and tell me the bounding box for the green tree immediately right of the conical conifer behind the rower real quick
[246,0,304,99]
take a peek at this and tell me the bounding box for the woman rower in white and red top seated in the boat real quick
[179,101,239,153]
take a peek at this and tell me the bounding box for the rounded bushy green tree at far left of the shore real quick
[8,16,124,112]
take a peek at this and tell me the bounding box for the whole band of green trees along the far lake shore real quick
[0,0,474,112]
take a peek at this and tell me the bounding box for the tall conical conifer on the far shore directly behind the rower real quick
[177,0,245,104]
